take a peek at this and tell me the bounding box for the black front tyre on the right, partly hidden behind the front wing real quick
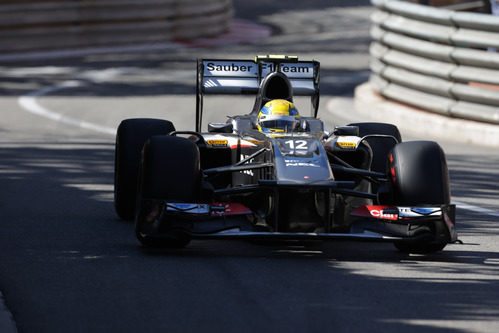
[389,141,450,253]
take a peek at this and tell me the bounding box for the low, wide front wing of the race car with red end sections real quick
[137,200,457,243]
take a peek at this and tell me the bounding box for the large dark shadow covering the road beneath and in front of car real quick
[0,137,499,332]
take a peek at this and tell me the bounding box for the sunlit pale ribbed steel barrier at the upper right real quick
[370,0,499,124]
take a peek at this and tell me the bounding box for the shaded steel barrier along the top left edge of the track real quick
[0,0,232,54]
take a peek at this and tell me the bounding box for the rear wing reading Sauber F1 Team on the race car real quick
[196,55,320,132]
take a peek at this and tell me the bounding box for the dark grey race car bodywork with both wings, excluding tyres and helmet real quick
[132,57,457,249]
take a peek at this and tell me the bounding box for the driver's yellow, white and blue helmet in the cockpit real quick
[257,99,300,132]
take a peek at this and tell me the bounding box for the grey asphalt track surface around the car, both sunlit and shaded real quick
[0,0,499,332]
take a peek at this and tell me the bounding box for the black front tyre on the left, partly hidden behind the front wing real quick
[136,136,201,248]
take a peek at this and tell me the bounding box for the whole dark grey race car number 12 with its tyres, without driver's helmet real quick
[114,56,457,253]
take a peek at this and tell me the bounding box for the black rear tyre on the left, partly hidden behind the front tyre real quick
[114,118,175,220]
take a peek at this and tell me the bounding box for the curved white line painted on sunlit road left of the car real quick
[18,81,116,135]
